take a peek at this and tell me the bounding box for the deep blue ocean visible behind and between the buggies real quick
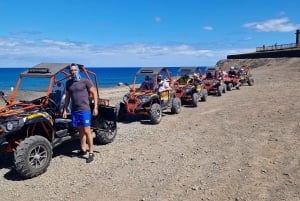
[0,66,206,91]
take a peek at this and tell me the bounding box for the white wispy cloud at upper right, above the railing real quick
[244,17,300,32]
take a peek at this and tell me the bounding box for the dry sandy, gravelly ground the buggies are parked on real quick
[0,58,300,201]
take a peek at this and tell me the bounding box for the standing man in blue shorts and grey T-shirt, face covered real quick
[63,64,98,163]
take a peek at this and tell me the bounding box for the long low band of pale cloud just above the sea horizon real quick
[0,38,252,67]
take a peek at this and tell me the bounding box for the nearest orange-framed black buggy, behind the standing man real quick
[0,63,117,178]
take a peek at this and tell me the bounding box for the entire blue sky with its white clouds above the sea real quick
[0,0,300,67]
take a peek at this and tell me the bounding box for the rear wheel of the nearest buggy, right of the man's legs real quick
[94,116,117,145]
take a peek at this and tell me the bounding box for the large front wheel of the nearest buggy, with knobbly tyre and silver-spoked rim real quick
[14,135,52,178]
